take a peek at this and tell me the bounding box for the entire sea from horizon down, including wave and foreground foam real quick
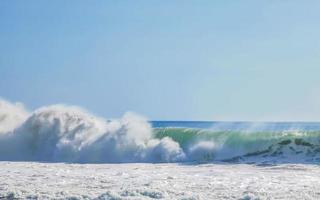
[0,100,320,199]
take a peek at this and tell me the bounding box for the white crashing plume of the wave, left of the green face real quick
[0,99,185,163]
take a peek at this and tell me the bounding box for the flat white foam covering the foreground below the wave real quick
[0,162,320,200]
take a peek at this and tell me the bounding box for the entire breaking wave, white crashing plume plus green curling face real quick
[0,97,320,163]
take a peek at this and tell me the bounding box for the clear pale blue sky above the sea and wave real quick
[0,0,320,121]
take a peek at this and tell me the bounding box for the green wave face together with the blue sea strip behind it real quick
[151,121,320,163]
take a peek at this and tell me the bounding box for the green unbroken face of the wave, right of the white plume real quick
[154,128,320,162]
